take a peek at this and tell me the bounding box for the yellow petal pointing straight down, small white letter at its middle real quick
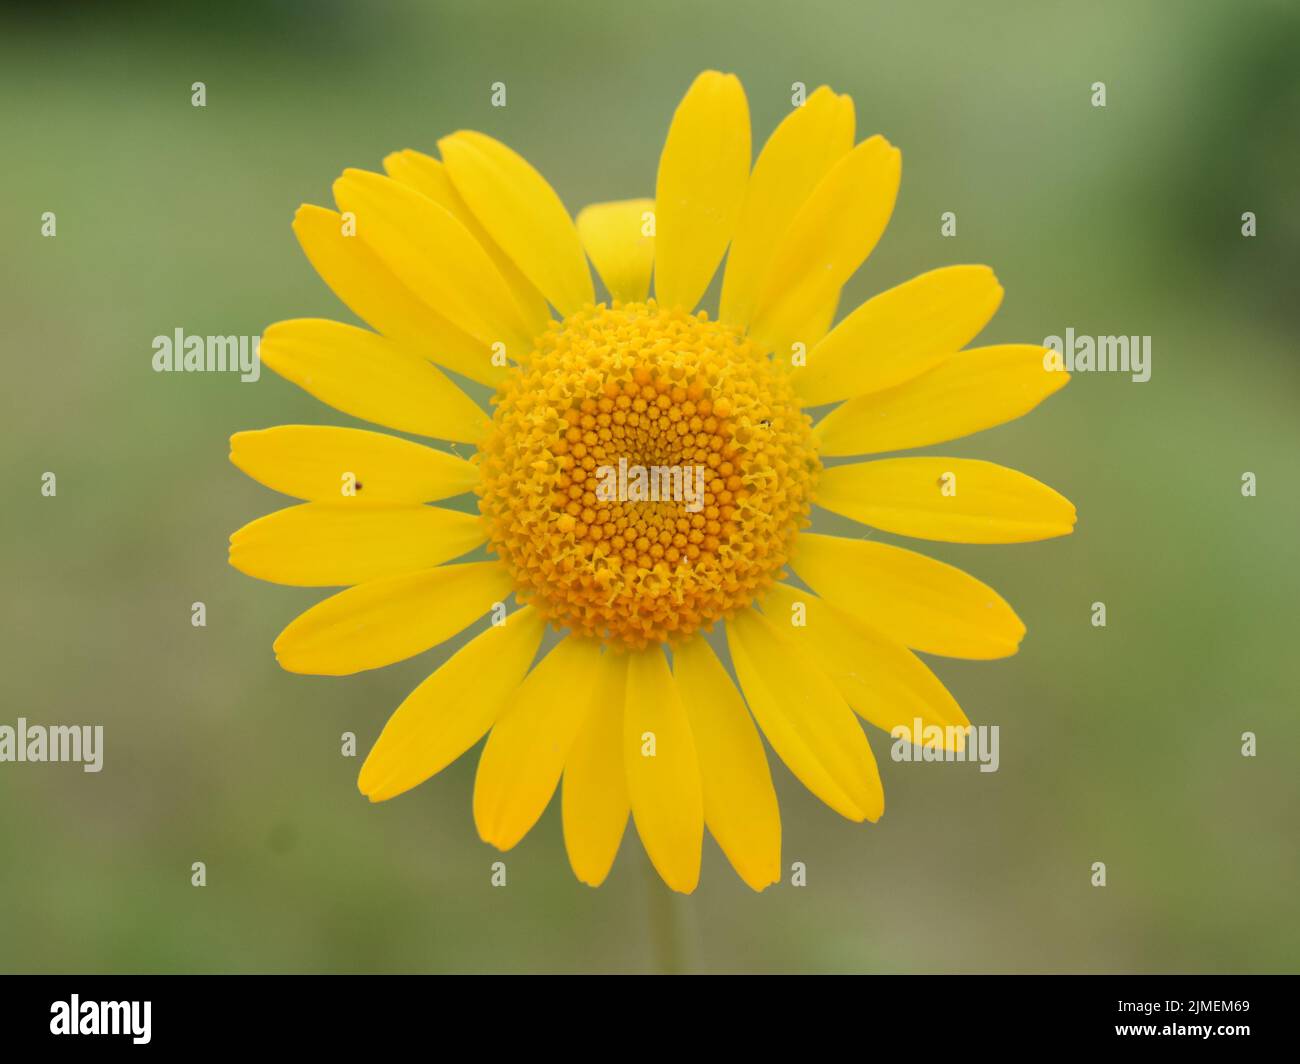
[623,646,705,894]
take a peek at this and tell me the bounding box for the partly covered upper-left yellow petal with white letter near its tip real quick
[294,203,506,386]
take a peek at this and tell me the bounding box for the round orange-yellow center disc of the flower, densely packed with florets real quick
[478,300,820,649]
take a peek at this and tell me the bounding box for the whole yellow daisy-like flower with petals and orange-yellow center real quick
[230,72,1075,892]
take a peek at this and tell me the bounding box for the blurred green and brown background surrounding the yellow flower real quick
[0,0,1300,972]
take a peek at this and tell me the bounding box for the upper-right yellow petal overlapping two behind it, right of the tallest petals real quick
[748,137,902,351]
